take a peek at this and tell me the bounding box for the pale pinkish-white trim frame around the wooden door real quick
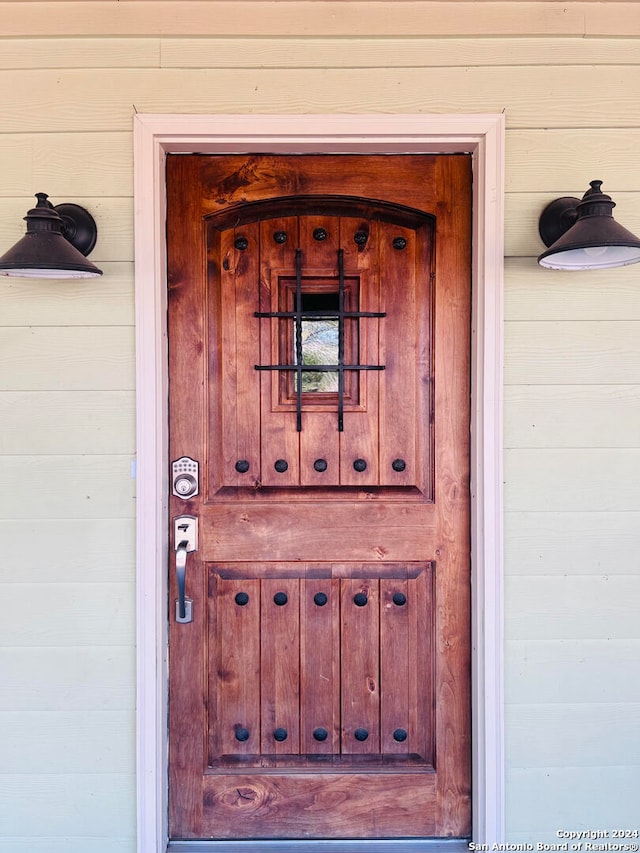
[133,113,505,853]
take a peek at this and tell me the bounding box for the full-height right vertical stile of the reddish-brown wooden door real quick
[433,153,471,831]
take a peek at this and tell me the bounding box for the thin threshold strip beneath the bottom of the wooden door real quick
[167,838,469,853]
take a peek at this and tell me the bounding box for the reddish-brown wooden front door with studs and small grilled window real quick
[167,154,471,839]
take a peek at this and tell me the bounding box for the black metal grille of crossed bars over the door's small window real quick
[254,249,387,432]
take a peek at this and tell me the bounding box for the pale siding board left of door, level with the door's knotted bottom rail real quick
[0,773,135,837]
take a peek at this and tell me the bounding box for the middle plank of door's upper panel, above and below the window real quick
[300,216,340,486]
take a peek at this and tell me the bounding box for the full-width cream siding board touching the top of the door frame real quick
[3,67,640,133]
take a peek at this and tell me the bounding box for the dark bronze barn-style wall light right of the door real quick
[538,181,640,270]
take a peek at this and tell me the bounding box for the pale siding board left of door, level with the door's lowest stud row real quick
[0,709,135,772]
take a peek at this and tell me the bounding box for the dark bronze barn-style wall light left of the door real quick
[0,193,102,278]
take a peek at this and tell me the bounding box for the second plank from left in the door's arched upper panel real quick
[254,216,300,486]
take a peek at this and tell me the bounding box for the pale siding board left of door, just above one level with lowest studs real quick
[0,648,135,708]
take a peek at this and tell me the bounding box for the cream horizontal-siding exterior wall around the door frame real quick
[0,0,640,853]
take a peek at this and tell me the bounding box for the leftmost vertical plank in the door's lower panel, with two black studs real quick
[215,578,260,755]
